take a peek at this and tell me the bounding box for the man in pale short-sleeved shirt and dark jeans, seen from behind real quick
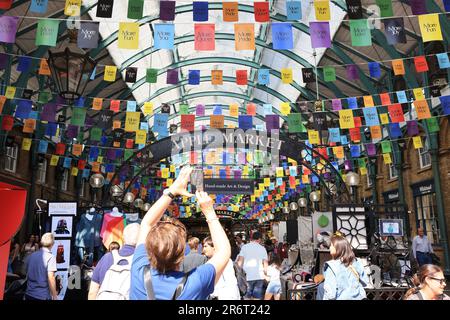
[237,231,268,300]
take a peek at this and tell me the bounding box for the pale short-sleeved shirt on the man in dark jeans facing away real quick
[239,242,268,281]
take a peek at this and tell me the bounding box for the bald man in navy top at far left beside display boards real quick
[25,233,58,300]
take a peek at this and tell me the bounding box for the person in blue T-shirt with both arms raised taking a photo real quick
[130,167,231,300]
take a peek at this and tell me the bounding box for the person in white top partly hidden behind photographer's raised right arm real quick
[203,237,241,300]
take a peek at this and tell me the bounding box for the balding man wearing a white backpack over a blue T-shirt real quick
[88,223,140,300]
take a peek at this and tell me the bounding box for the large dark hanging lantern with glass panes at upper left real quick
[48,29,97,104]
